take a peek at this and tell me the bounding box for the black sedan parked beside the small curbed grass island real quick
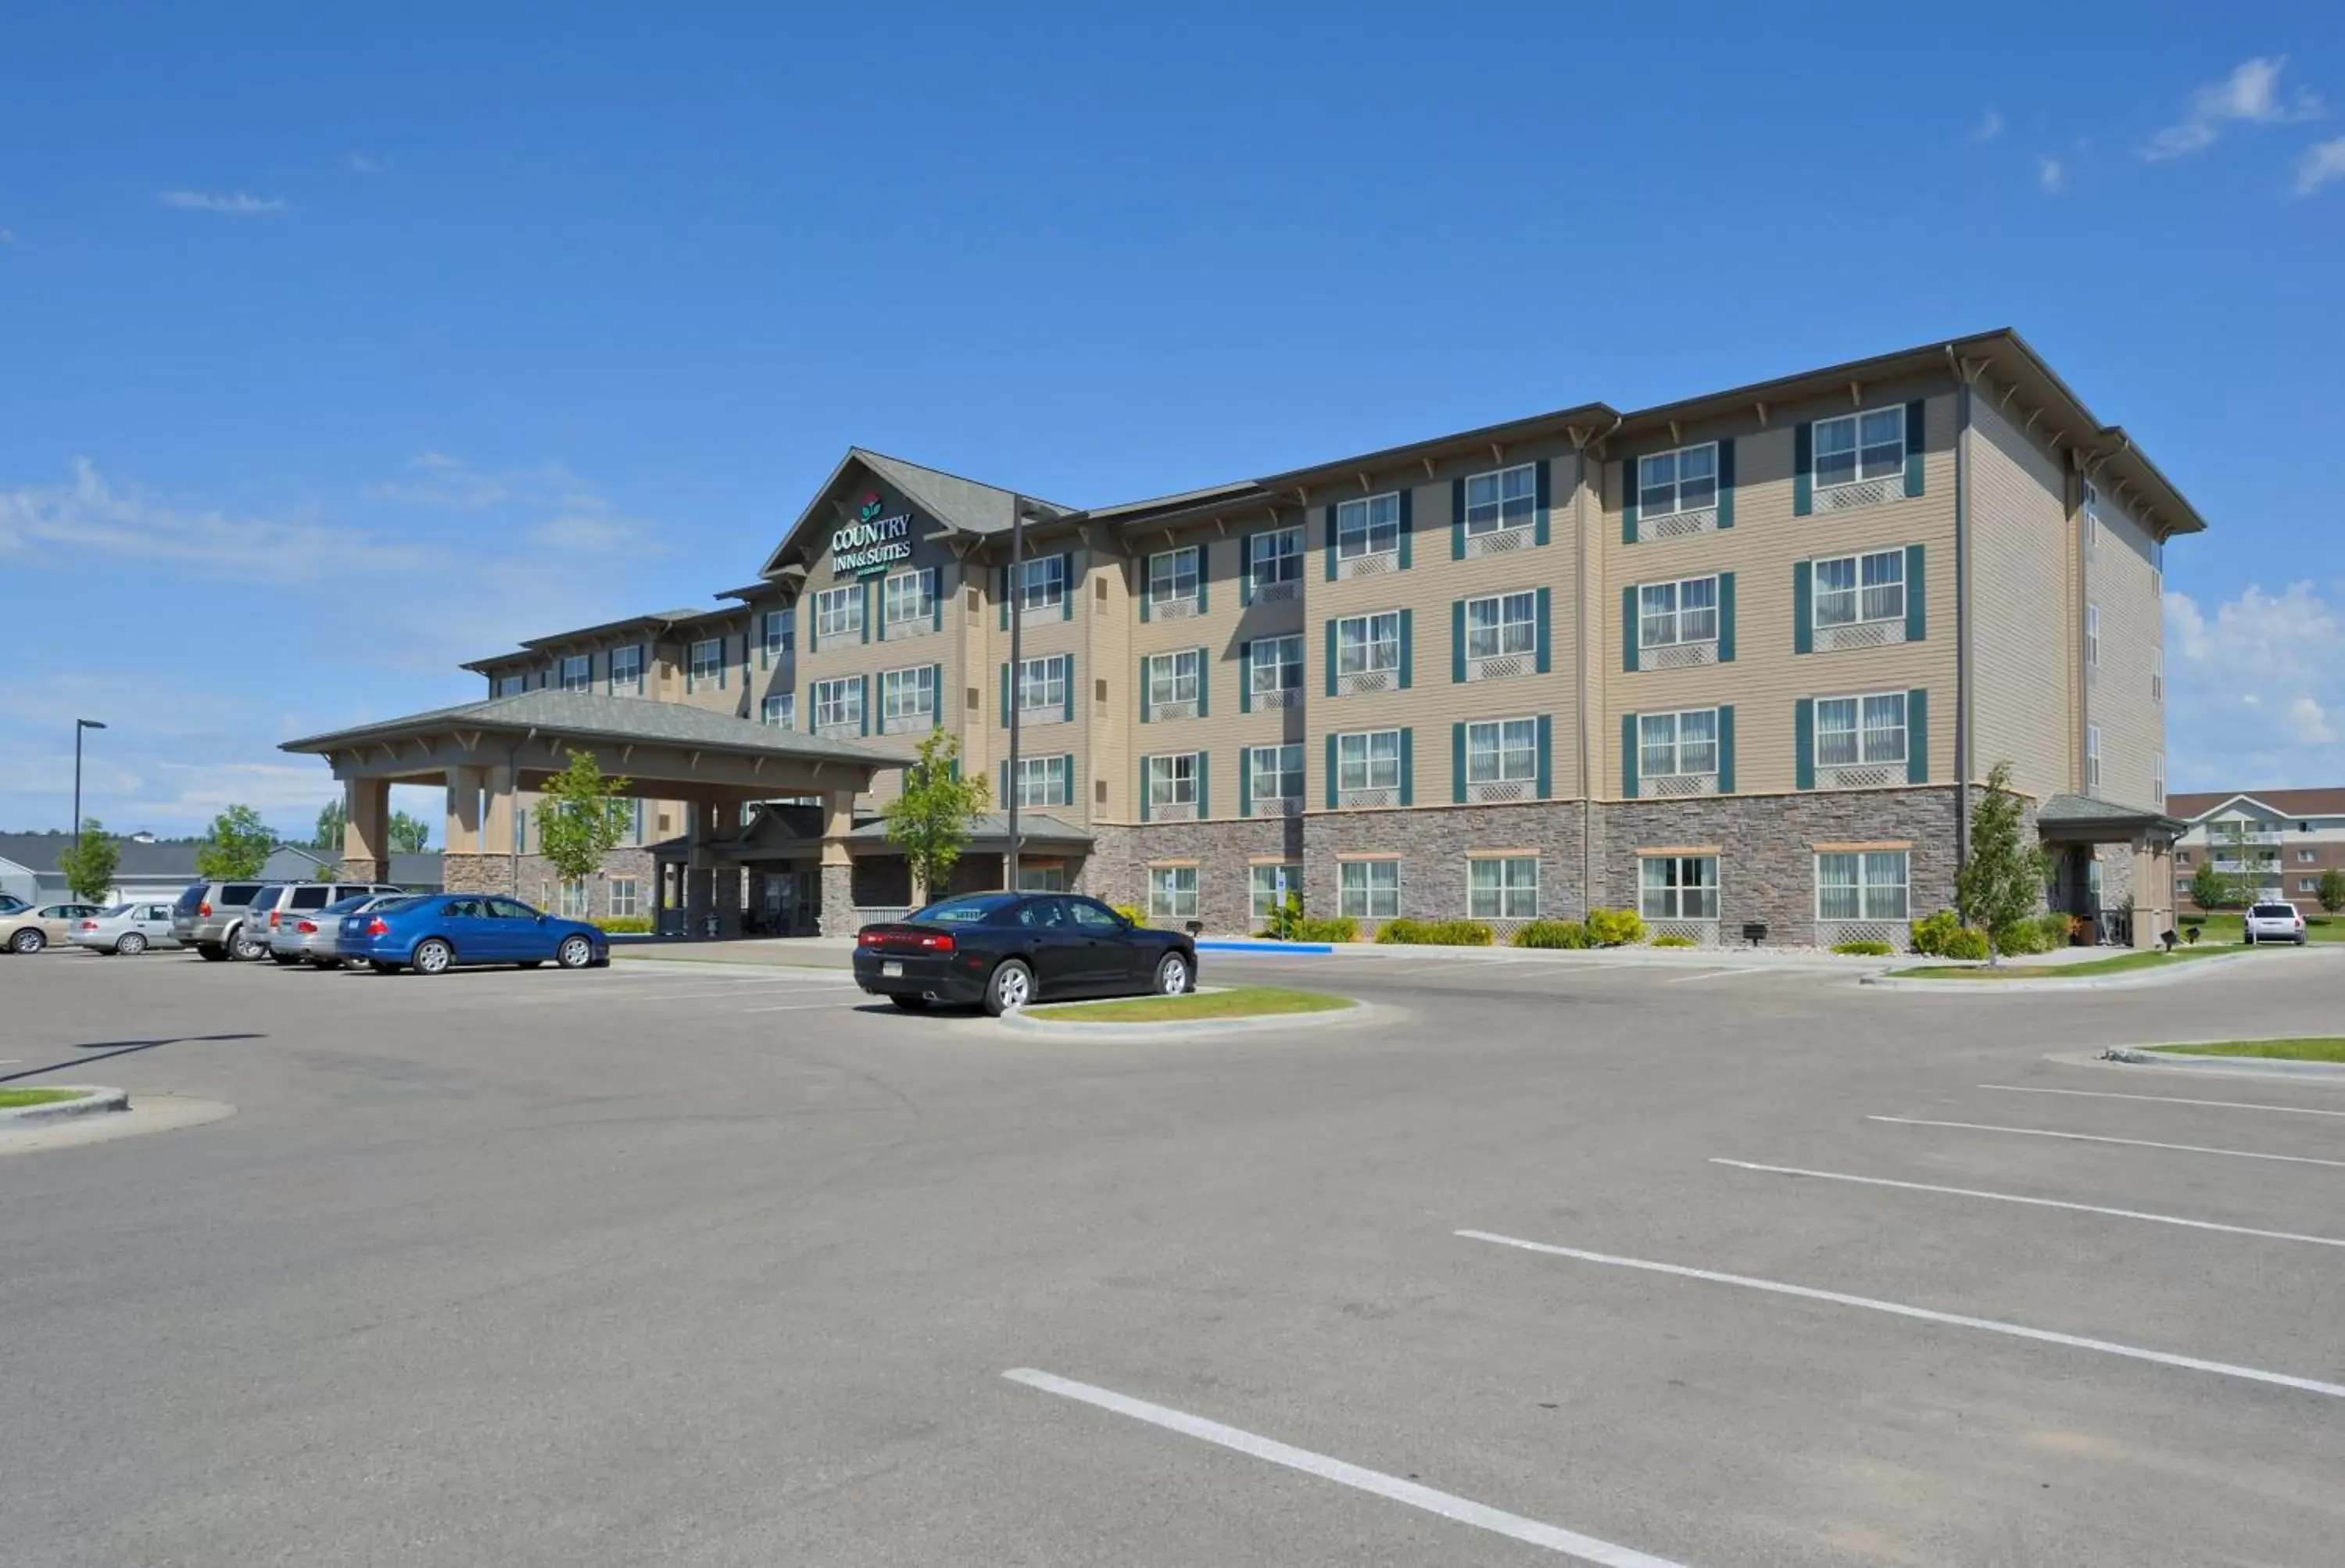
[856,893,1196,1017]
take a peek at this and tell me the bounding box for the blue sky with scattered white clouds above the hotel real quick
[0,0,2345,832]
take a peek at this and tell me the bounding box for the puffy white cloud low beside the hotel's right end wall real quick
[2167,582,2345,789]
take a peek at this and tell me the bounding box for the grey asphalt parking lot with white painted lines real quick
[0,951,2345,1568]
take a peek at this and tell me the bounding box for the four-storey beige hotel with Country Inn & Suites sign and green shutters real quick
[298,331,2204,944]
